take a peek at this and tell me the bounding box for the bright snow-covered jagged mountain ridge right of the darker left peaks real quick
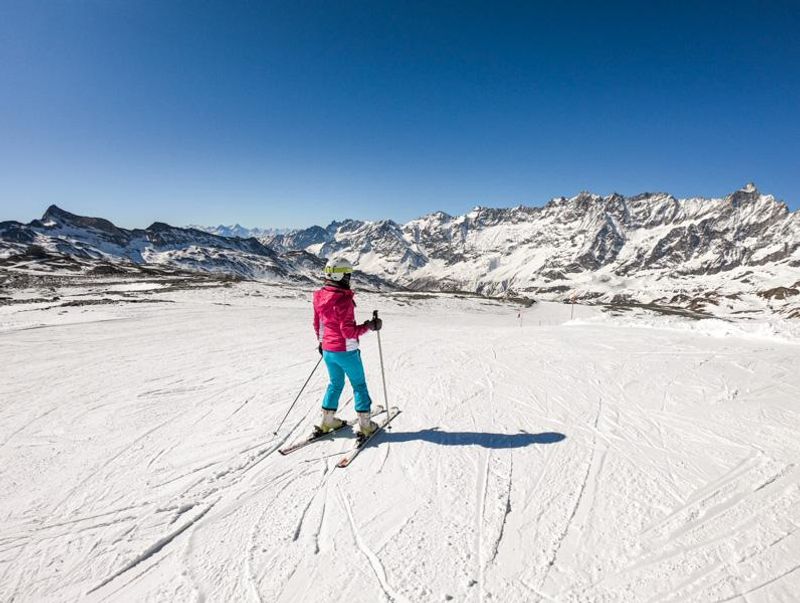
[265,184,800,311]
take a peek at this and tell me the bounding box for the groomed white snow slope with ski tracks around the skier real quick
[0,283,800,603]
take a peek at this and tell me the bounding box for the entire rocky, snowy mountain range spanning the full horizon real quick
[0,184,800,316]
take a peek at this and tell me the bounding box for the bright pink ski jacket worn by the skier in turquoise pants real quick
[314,285,369,352]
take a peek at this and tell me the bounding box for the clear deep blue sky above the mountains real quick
[0,0,800,227]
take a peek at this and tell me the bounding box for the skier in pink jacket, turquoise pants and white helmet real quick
[314,258,383,437]
